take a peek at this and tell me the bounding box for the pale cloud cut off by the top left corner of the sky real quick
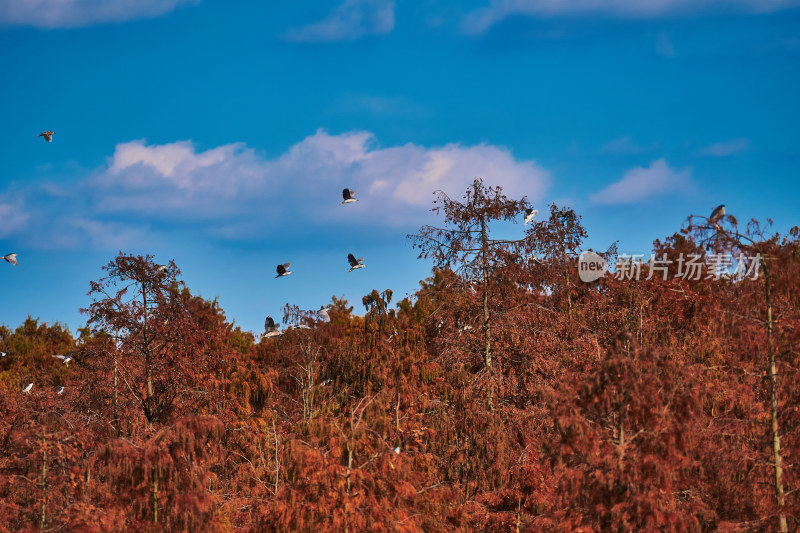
[0,0,200,28]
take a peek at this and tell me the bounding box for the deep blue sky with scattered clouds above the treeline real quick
[0,0,800,333]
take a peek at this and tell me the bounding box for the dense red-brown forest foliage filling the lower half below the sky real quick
[0,181,800,532]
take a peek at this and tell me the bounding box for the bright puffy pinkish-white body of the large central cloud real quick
[90,130,549,227]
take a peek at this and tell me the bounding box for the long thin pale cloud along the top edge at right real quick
[463,0,800,34]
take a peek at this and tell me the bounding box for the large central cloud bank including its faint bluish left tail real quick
[9,130,550,248]
